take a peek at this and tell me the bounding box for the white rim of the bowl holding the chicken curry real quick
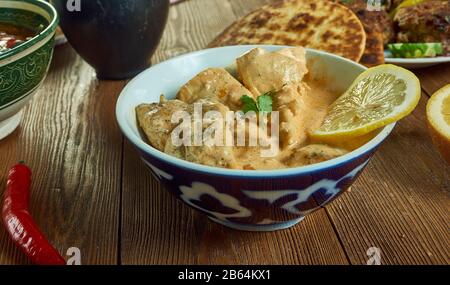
[116,45,396,178]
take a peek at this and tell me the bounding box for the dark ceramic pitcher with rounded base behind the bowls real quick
[50,0,169,79]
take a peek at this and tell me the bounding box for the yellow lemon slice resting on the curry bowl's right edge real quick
[311,64,421,141]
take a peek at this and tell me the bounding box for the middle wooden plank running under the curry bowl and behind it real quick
[121,0,348,264]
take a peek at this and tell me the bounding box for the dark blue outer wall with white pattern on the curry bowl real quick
[141,146,375,231]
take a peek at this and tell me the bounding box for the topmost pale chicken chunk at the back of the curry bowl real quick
[237,47,308,96]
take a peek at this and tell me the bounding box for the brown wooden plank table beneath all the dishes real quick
[0,0,450,264]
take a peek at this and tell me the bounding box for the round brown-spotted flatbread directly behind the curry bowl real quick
[209,0,366,61]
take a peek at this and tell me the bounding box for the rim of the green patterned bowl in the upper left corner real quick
[0,0,59,60]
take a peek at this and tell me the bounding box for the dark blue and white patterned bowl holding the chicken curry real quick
[116,46,394,231]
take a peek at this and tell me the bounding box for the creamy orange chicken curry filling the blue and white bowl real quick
[136,47,368,170]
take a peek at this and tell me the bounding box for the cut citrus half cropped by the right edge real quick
[427,84,450,163]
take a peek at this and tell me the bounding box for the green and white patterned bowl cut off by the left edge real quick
[0,0,58,139]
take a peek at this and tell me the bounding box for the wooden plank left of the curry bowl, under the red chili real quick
[0,45,123,264]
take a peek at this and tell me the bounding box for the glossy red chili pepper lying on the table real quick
[2,163,66,265]
